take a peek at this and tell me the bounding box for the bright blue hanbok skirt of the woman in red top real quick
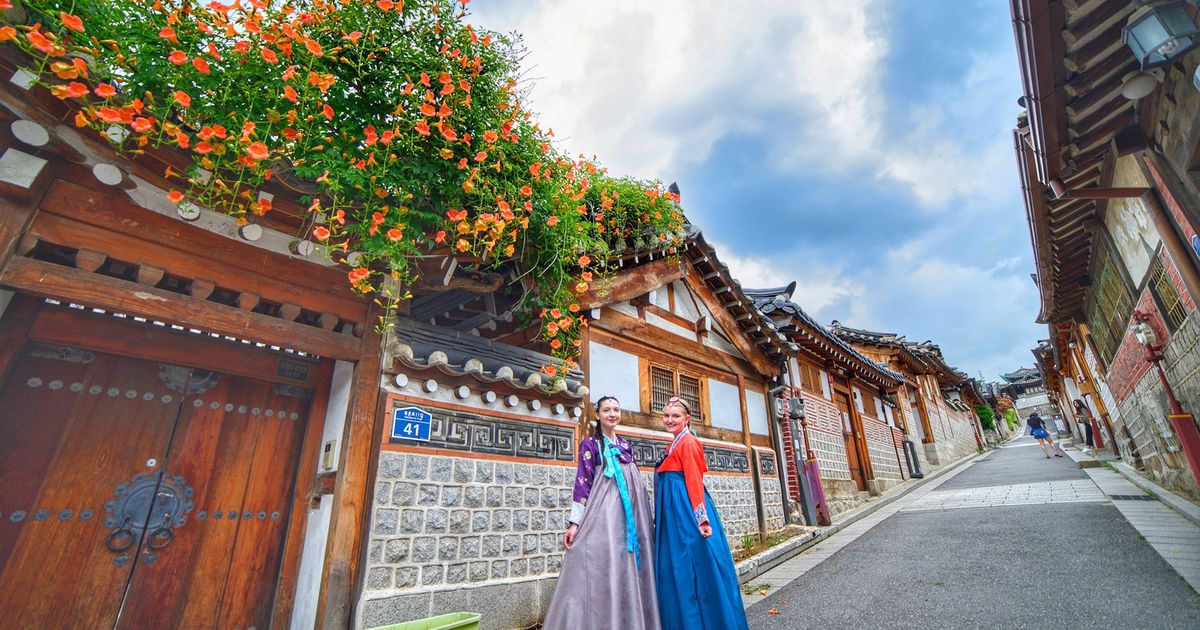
[654,472,746,630]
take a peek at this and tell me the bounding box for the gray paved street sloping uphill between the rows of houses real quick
[746,437,1200,629]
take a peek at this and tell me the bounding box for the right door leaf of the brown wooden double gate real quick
[118,370,308,629]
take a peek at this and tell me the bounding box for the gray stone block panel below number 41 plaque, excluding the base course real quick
[365,451,575,600]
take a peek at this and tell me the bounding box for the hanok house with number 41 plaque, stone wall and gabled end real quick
[358,222,785,628]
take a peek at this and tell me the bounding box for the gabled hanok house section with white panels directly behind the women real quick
[581,226,790,540]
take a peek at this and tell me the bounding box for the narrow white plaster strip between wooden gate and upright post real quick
[292,361,354,630]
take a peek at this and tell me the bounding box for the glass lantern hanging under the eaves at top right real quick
[1121,0,1200,71]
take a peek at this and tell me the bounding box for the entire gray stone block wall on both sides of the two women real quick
[360,451,784,628]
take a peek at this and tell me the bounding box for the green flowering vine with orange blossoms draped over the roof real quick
[0,0,683,373]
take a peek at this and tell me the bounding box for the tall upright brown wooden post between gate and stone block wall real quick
[317,302,383,630]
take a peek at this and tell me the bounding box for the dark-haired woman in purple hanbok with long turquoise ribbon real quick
[544,396,659,630]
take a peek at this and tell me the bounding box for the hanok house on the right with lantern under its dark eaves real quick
[1012,0,1200,497]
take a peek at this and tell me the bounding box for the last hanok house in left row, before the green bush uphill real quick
[830,322,983,467]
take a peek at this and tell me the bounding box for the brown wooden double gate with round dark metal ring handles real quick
[0,303,310,628]
